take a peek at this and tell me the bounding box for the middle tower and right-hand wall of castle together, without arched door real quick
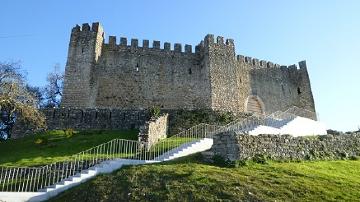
[205,35,315,114]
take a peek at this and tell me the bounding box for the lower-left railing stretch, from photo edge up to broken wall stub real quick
[0,139,138,192]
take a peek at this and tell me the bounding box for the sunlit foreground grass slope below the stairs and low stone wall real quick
[50,155,360,201]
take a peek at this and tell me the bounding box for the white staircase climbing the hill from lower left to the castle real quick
[0,106,326,202]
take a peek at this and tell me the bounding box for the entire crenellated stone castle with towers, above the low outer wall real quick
[62,23,316,118]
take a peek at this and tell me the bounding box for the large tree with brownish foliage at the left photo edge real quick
[0,62,45,140]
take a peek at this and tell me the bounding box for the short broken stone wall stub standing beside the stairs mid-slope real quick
[138,114,169,149]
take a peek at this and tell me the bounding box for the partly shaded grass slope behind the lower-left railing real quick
[0,130,138,166]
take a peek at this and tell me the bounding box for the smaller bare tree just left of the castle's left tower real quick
[43,64,64,108]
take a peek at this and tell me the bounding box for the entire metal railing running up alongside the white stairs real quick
[0,105,314,192]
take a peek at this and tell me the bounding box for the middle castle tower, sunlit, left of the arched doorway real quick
[204,34,245,112]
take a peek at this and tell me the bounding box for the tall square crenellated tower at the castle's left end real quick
[62,23,104,108]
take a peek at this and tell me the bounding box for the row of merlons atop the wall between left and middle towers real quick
[104,36,203,54]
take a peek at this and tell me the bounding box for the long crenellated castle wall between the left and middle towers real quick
[93,40,210,109]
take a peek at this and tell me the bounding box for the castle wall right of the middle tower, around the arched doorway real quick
[236,55,316,116]
